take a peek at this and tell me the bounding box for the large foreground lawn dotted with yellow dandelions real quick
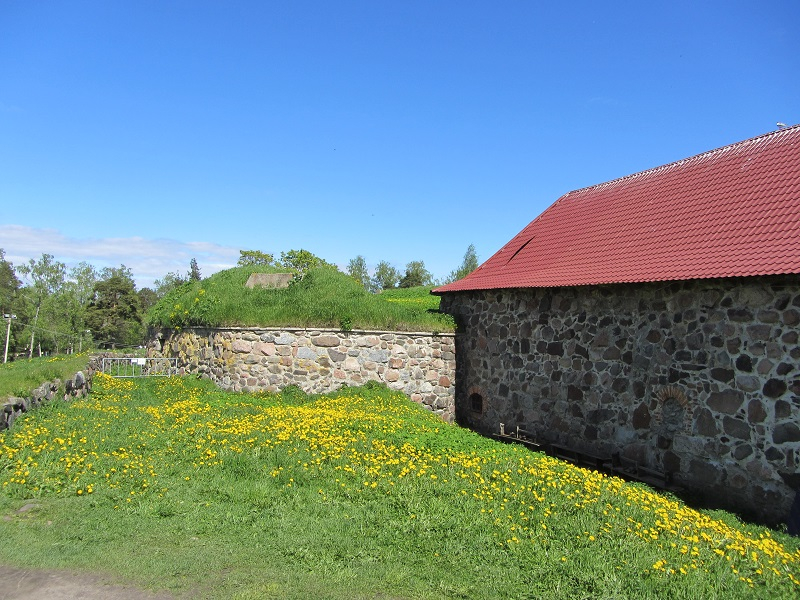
[0,376,800,599]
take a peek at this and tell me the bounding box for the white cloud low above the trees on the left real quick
[0,225,239,288]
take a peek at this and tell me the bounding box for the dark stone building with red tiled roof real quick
[433,126,800,522]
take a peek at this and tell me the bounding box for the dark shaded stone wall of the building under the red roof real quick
[441,276,800,522]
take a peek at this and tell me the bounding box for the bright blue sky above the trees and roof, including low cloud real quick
[0,0,800,286]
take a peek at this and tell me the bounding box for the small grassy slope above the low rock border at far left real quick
[0,353,88,400]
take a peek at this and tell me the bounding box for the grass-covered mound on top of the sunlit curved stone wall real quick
[147,267,454,332]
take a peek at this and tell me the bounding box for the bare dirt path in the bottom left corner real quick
[0,566,173,600]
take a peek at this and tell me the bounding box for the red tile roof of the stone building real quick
[434,125,800,294]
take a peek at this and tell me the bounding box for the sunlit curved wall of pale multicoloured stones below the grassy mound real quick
[151,328,455,421]
